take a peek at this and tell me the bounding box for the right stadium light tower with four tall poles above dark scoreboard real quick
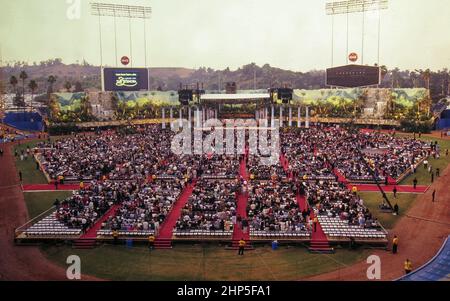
[325,0,388,65]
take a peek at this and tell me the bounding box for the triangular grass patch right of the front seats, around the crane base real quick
[358,192,418,230]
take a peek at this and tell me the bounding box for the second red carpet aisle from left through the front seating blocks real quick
[155,180,197,249]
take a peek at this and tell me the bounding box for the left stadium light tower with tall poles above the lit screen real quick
[91,2,152,68]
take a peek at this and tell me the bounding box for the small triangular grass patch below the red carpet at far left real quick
[24,191,72,219]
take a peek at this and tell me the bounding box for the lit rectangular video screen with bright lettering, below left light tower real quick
[103,68,149,91]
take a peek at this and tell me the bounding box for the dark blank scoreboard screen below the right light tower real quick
[327,65,381,88]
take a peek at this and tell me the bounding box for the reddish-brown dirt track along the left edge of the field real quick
[0,143,95,280]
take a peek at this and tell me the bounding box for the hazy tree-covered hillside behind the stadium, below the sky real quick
[1,59,450,100]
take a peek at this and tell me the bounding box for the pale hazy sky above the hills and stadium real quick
[0,0,450,72]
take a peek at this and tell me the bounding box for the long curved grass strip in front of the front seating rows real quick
[41,245,369,281]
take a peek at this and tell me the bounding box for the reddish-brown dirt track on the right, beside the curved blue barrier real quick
[308,166,450,281]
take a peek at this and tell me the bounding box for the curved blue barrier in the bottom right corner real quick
[398,237,450,281]
